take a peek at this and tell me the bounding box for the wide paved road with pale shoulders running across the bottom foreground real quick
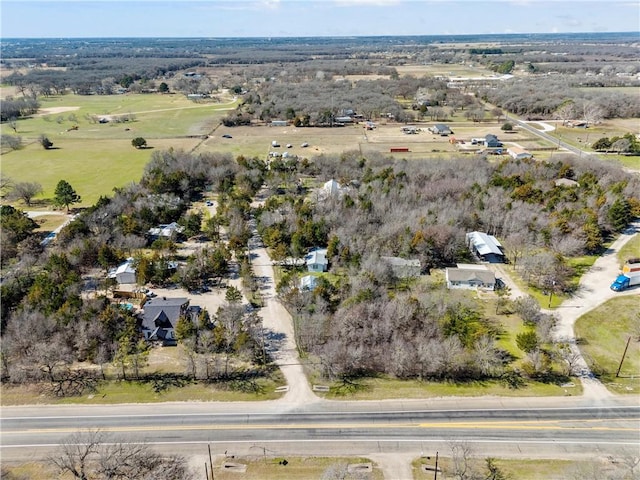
[0,399,640,461]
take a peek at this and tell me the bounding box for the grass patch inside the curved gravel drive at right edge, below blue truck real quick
[575,295,640,395]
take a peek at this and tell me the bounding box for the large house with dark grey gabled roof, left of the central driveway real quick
[142,297,194,345]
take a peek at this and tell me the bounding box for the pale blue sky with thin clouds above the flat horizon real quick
[0,0,640,38]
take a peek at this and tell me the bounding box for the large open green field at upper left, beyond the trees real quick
[1,94,234,206]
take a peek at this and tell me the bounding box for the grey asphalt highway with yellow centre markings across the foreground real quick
[0,406,640,459]
